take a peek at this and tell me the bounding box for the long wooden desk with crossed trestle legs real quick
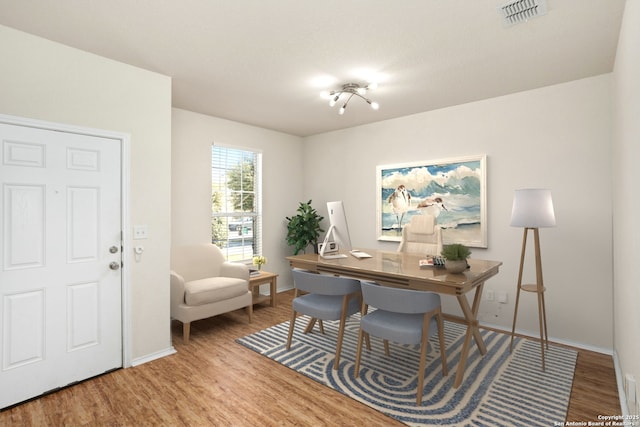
[287,249,502,388]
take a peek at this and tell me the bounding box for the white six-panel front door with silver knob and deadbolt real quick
[0,123,122,408]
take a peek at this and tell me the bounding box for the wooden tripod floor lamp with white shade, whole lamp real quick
[509,188,556,371]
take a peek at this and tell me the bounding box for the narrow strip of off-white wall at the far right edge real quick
[612,0,640,414]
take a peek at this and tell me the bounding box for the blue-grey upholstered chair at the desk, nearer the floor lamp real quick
[354,282,449,405]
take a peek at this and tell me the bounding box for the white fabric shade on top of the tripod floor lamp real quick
[511,188,556,228]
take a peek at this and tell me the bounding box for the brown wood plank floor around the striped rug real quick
[0,291,620,427]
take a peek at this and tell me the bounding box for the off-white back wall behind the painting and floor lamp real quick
[304,75,613,351]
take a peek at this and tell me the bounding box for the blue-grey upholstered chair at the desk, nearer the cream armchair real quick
[287,270,362,369]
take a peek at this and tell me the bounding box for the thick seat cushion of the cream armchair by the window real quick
[184,277,249,306]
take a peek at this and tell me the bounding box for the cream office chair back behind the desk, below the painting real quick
[398,214,442,256]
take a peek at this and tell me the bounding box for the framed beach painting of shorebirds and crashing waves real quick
[376,155,487,248]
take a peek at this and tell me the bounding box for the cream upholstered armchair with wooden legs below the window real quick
[171,243,253,343]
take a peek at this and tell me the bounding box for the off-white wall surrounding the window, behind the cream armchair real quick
[172,109,306,289]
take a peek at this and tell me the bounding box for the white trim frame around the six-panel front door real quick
[0,114,133,368]
